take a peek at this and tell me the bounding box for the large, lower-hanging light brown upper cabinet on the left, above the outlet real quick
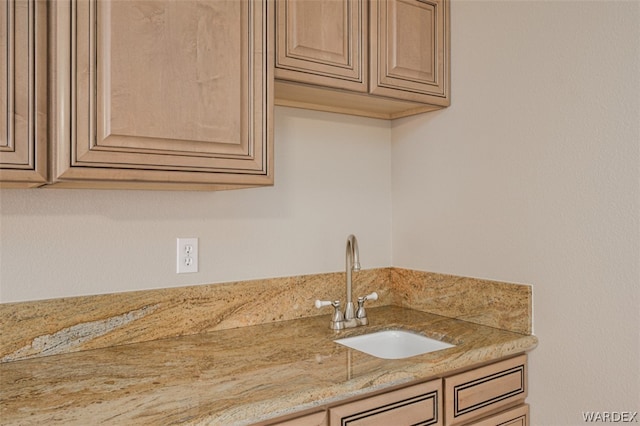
[0,0,275,189]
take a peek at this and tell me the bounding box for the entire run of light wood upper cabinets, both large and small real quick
[0,0,449,190]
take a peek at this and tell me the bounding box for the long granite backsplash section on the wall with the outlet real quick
[0,268,391,362]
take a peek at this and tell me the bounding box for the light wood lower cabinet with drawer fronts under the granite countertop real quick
[267,355,529,426]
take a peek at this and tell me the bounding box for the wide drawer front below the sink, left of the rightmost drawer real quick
[329,380,442,426]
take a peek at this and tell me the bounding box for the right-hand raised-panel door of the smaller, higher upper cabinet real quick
[370,0,450,106]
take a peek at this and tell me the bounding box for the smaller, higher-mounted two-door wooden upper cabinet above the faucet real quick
[275,0,450,119]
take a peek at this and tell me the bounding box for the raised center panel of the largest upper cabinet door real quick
[98,1,242,149]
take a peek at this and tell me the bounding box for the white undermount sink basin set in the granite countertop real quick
[334,330,455,359]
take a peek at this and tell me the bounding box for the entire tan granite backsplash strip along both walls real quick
[0,268,531,363]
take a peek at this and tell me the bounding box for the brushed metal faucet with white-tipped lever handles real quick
[316,235,378,330]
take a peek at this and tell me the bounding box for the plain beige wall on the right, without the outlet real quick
[392,0,640,426]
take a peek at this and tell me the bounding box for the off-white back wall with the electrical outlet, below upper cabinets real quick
[0,108,391,302]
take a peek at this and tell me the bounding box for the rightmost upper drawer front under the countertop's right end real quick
[444,355,527,425]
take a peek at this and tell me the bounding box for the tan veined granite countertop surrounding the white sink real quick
[0,306,537,425]
